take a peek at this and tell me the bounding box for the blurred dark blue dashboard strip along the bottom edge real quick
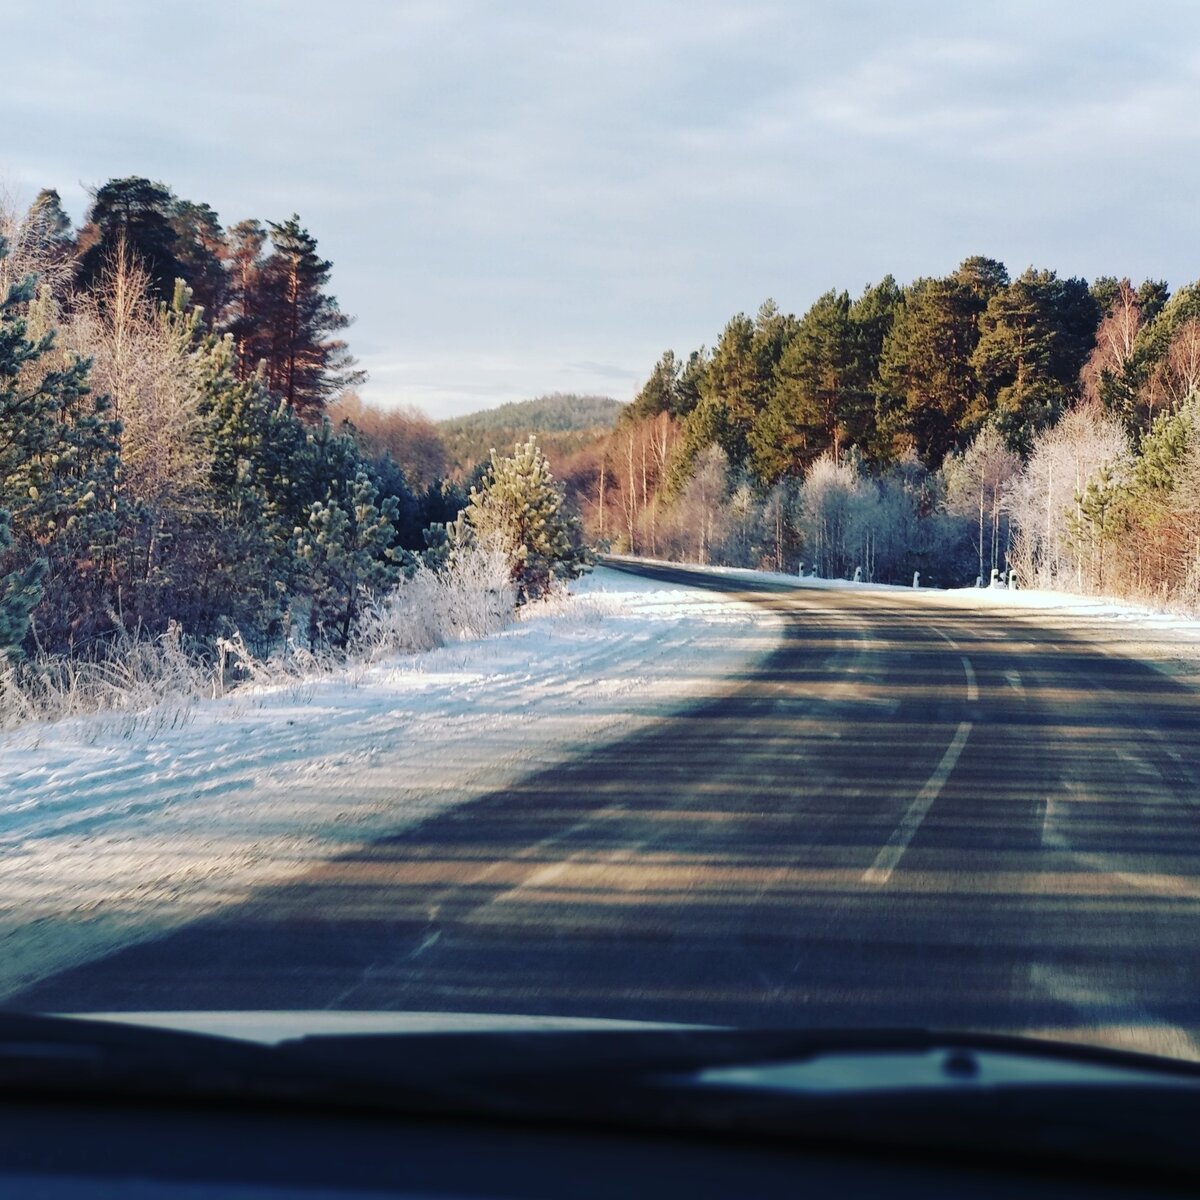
[0,1096,1172,1200]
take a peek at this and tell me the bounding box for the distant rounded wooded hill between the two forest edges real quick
[438,392,625,474]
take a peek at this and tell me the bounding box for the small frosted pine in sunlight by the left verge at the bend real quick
[457,437,590,602]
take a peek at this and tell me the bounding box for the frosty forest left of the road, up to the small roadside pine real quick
[0,178,584,718]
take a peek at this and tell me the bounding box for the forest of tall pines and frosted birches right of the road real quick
[562,257,1200,606]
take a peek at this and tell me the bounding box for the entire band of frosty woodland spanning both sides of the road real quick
[0,178,1200,715]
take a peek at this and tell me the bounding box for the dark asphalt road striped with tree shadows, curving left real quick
[14,569,1200,1056]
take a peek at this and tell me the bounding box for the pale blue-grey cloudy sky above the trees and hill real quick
[0,0,1200,416]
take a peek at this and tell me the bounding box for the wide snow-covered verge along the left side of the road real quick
[0,568,782,1001]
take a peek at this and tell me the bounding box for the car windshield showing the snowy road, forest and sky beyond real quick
[0,0,1200,1062]
